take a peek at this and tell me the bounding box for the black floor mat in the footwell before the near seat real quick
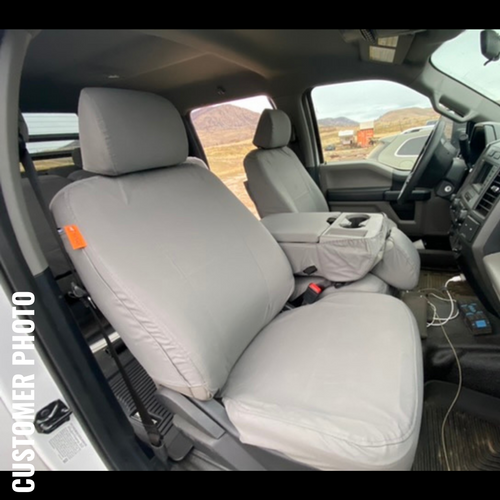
[413,382,500,471]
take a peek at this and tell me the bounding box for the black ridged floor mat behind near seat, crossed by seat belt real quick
[109,357,192,460]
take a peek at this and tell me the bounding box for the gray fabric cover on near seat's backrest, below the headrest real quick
[51,162,293,400]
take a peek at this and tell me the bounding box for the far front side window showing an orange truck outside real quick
[311,80,439,170]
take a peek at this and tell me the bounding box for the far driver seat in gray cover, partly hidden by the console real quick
[244,109,420,295]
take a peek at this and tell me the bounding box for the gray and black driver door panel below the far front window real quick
[318,160,451,239]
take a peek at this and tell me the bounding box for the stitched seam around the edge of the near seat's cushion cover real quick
[226,295,418,448]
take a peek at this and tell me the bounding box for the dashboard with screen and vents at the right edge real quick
[450,122,500,316]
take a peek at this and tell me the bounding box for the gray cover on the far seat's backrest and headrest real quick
[244,109,329,217]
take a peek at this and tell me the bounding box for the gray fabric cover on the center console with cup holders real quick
[268,213,390,282]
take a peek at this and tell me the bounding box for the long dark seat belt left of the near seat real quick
[19,134,168,464]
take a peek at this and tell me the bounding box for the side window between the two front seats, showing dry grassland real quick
[191,96,272,217]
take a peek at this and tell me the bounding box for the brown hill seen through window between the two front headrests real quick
[192,104,260,131]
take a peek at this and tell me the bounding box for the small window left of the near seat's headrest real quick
[23,113,80,175]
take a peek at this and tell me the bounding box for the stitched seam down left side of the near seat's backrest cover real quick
[64,184,216,395]
